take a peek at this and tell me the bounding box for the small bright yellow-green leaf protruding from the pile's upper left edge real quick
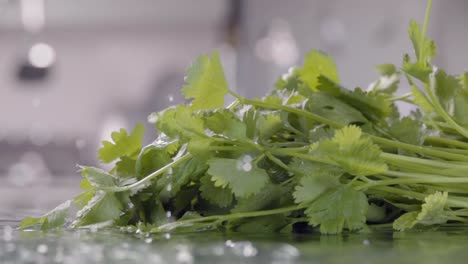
[98,124,145,163]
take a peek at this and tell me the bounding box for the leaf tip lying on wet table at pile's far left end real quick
[19,200,71,231]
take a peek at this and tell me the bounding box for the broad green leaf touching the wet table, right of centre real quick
[304,186,368,234]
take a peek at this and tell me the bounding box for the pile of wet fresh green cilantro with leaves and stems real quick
[21,1,468,234]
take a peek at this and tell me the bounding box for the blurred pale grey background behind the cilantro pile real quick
[0,0,468,215]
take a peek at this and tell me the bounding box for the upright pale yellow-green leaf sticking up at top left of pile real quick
[182,52,229,109]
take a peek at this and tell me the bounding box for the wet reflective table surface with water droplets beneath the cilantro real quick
[0,218,468,264]
